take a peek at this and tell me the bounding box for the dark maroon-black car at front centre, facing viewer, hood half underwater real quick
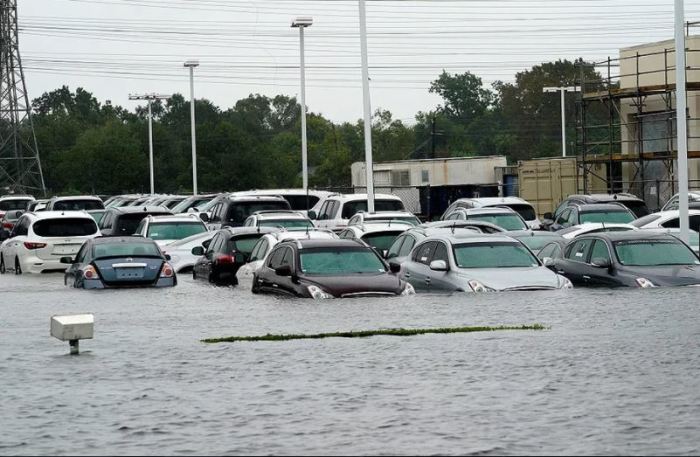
[252,239,415,299]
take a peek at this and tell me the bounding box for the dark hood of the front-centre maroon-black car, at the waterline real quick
[299,273,405,297]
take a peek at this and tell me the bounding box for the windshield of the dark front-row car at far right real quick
[614,239,700,267]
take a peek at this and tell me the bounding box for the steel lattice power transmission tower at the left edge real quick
[0,0,46,194]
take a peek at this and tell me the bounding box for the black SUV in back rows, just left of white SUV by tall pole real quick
[200,195,292,230]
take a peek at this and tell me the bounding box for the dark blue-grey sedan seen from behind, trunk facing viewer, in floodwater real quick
[61,237,177,289]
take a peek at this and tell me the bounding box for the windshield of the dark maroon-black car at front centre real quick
[299,248,386,276]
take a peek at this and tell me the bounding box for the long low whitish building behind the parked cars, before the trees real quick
[351,156,508,187]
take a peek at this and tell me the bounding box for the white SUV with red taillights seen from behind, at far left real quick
[0,211,100,274]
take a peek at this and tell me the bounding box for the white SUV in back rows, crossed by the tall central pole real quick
[309,194,406,232]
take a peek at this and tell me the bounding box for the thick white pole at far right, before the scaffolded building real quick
[675,0,690,243]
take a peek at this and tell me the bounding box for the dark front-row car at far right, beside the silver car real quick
[546,231,700,288]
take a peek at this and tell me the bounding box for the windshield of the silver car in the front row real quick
[454,242,540,268]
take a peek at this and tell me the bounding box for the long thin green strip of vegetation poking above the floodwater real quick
[202,324,547,344]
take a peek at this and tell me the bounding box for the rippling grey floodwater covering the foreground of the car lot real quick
[0,275,700,455]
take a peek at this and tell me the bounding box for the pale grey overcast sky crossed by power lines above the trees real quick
[18,0,700,123]
